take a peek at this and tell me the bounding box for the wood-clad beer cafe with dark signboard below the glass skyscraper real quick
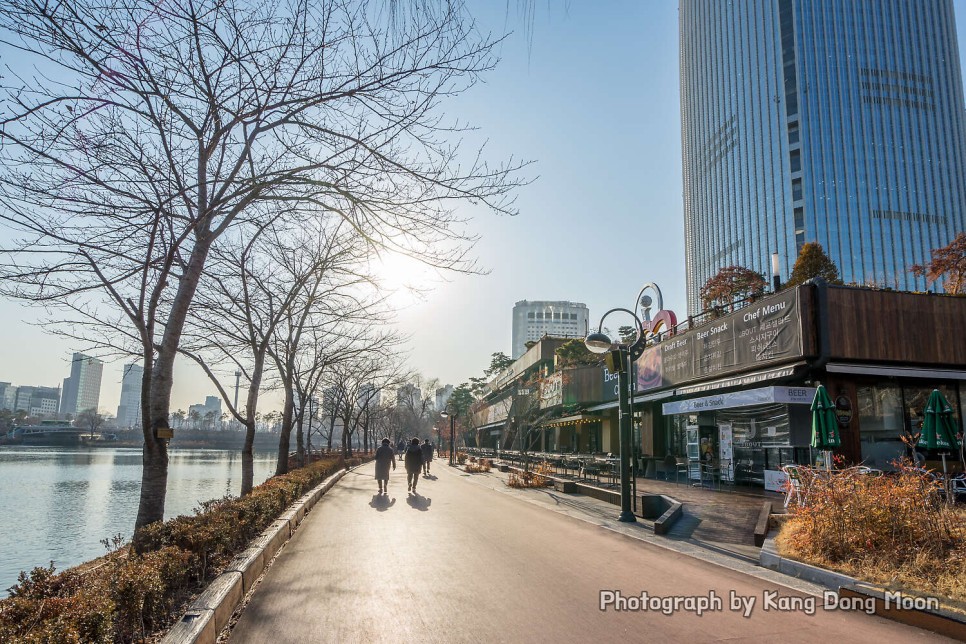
[636,280,966,490]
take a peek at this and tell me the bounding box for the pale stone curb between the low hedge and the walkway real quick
[161,466,359,644]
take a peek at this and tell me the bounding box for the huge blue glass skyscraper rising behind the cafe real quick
[679,0,966,314]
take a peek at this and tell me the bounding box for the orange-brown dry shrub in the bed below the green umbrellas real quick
[777,463,966,601]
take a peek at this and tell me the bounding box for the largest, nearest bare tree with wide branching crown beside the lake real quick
[0,0,521,529]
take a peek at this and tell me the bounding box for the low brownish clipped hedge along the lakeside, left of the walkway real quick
[0,459,348,644]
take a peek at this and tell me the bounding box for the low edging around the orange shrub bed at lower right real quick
[759,531,966,640]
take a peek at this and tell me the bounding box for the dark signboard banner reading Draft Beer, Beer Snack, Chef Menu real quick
[636,289,803,391]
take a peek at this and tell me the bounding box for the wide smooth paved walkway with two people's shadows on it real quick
[231,464,943,644]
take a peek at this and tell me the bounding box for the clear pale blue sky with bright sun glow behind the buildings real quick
[0,0,966,413]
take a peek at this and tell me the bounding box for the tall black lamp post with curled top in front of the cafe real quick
[584,284,662,523]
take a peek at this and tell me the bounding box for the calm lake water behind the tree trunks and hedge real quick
[0,447,276,597]
